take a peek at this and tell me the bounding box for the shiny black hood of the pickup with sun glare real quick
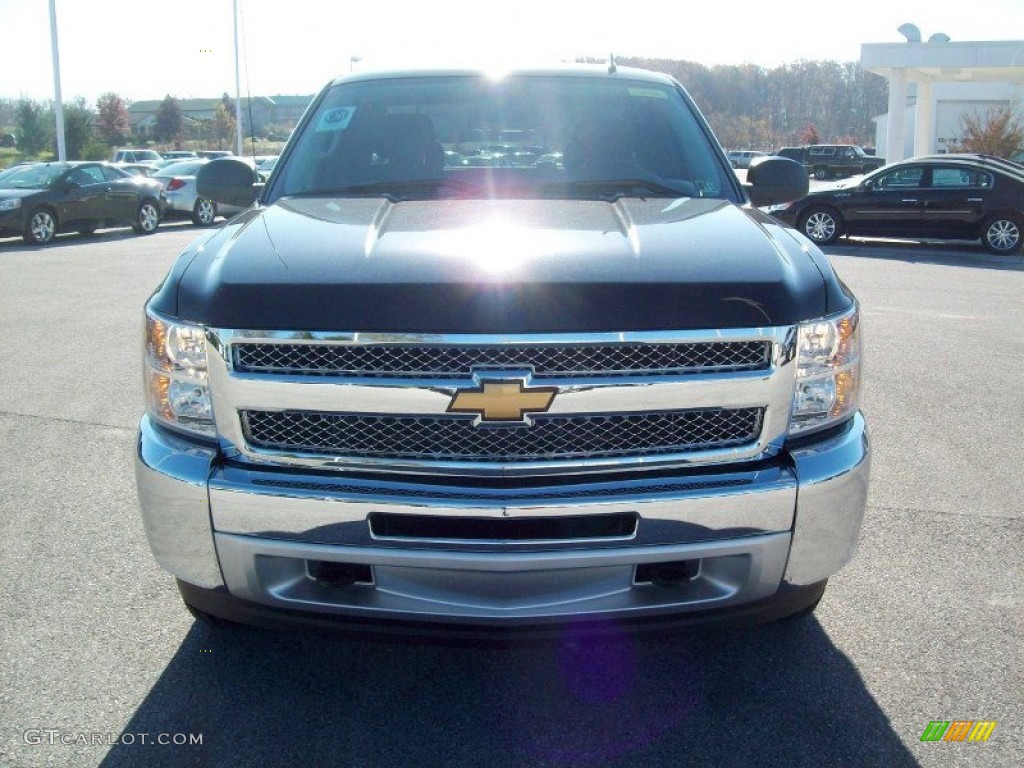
[163,198,836,333]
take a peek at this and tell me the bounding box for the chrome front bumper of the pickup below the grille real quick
[136,415,869,625]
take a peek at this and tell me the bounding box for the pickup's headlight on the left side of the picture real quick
[143,312,216,436]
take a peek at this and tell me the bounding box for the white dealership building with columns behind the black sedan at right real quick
[860,35,1024,162]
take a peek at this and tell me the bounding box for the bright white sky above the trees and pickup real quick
[0,0,1024,102]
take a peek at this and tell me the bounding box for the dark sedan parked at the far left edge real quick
[0,162,165,245]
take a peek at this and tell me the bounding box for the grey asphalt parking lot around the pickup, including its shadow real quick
[0,219,1024,768]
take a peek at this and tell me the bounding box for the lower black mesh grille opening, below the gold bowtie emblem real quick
[240,408,764,463]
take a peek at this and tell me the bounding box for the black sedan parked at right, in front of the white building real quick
[768,155,1024,254]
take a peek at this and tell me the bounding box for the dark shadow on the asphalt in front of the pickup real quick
[101,617,924,768]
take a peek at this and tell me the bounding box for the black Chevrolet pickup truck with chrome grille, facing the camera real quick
[136,67,869,637]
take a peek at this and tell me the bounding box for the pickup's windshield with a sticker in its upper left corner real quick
[266,74,741,202]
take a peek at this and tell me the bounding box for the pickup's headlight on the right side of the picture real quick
[790,306,860,435]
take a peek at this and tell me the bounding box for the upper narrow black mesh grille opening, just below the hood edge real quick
[233,341,771,379]
